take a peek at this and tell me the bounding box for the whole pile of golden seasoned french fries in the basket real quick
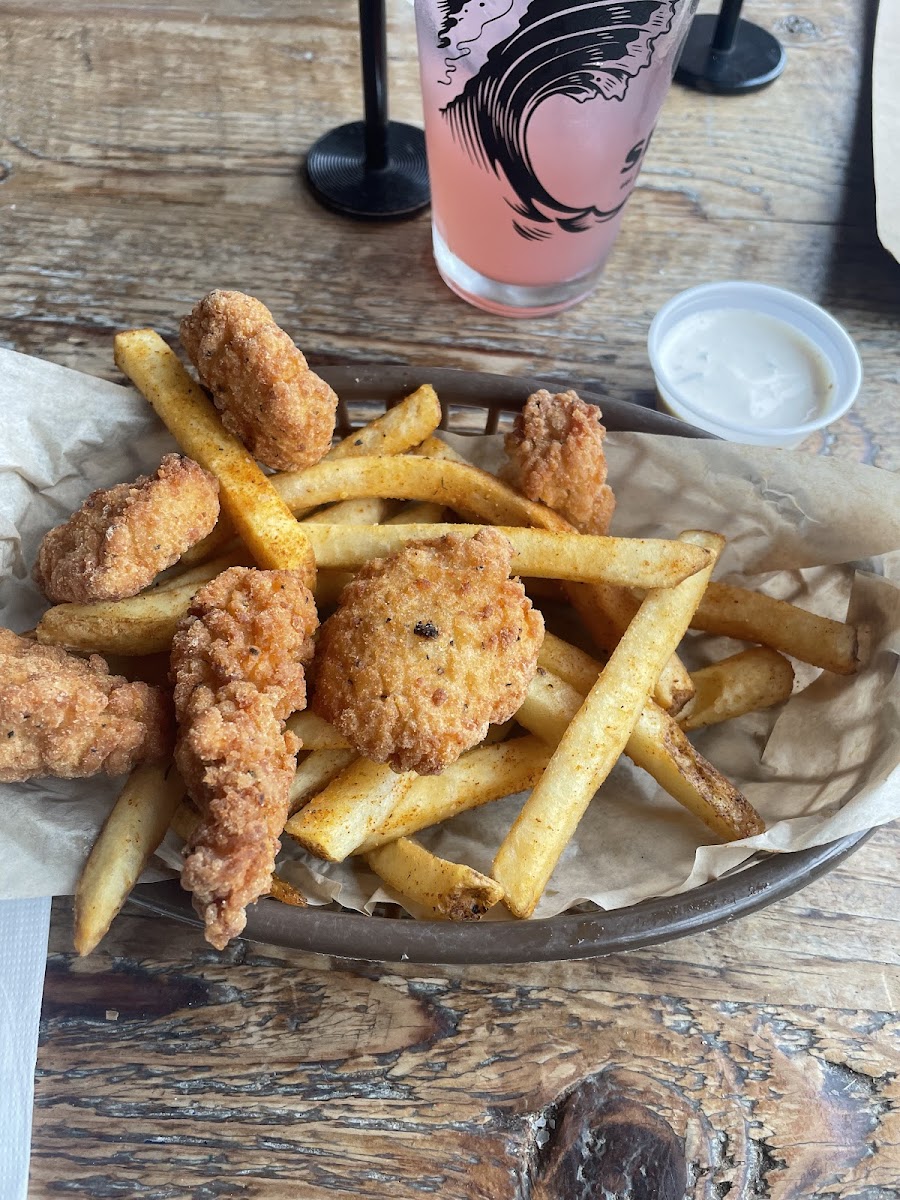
[36,330,858,954]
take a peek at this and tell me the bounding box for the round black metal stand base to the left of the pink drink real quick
[306,121,431,221]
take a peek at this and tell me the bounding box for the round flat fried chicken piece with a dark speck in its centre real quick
[311,529,544,775]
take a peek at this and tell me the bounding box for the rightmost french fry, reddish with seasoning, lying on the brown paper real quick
[691,583,859,674]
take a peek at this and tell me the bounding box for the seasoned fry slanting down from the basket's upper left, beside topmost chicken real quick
[115,329,316,587]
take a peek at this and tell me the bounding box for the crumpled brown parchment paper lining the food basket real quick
[0,350,900,917]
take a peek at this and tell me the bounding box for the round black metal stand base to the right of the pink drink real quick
[674,13,787,95]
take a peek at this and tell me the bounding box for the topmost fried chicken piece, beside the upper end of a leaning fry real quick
[181,290,337,470]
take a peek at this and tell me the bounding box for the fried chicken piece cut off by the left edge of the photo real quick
[0,629,174,784]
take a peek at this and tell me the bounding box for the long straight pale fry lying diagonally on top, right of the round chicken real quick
[493,532,724,917]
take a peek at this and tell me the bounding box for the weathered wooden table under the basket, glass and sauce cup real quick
[0,0,900,1200]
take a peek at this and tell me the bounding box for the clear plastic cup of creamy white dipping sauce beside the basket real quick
[647,280,863,446]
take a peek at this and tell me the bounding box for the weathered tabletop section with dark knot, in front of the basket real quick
[31,830,900,1200]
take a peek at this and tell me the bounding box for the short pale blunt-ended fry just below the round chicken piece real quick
[284,750,416,863]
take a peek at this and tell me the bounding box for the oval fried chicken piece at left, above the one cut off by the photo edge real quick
[34,454,218,604]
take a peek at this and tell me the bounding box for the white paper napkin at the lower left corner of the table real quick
[0,896,50,1200]
